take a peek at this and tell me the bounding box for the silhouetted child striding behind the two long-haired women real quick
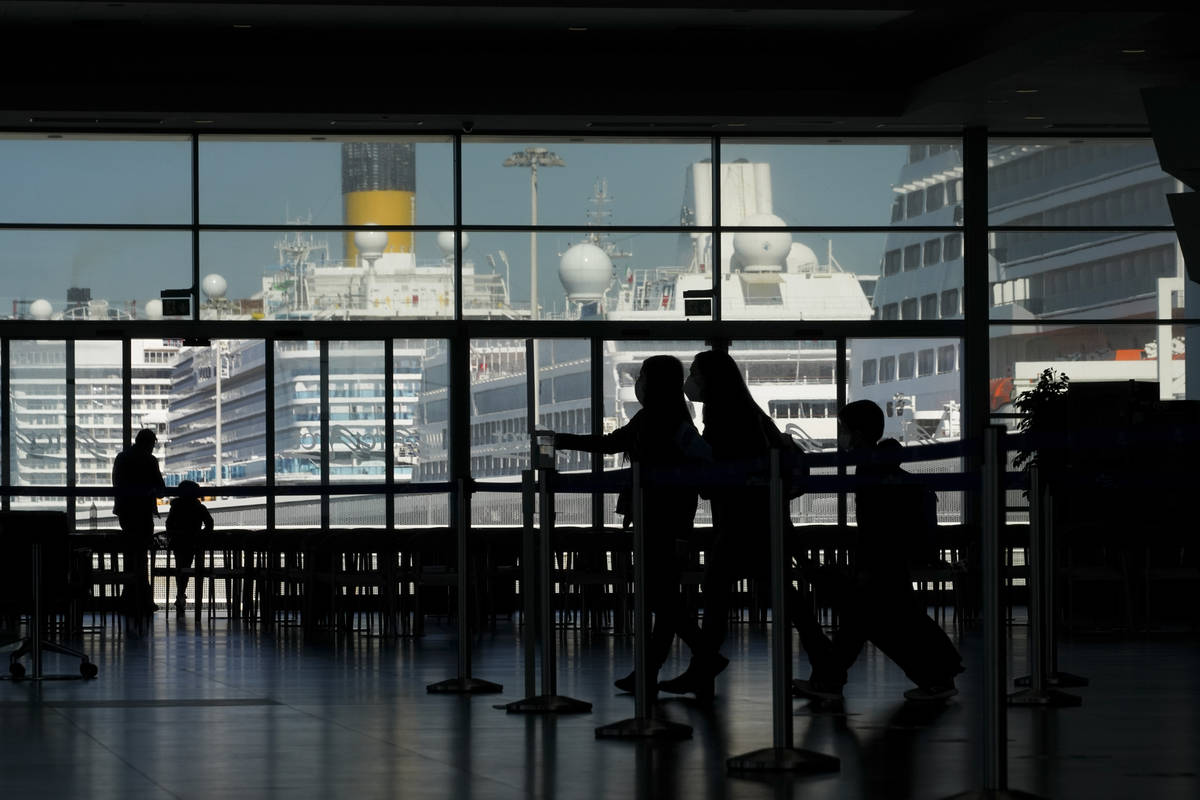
[793,401,962,700]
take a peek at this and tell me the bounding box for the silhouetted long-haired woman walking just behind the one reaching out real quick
[659,350,821,700]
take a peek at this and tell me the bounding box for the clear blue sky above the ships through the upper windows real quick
[0,136,907,314]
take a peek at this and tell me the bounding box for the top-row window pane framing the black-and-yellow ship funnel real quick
[199,136,454,225]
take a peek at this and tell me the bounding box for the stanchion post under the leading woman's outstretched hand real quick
[497,441,592,714]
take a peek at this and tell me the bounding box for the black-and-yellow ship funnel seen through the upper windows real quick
[342,142,416,261]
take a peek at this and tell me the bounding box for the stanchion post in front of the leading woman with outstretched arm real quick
[595,459,691,740]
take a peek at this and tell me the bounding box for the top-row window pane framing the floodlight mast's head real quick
[462,138,713,227]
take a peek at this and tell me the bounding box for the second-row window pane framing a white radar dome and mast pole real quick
[463,230,713,319]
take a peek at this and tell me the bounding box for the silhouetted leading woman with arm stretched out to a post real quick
[554,355,712,692]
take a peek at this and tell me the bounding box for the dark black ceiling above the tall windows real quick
[0,0,1200,136]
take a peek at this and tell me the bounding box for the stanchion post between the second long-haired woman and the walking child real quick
[726,447,841,774]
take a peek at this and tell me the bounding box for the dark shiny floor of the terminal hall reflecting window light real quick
[0,612,1200,800]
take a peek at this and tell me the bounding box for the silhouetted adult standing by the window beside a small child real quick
[113,428,167,618]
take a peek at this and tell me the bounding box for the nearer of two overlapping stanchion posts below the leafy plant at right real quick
[1008,464,1084,708]
